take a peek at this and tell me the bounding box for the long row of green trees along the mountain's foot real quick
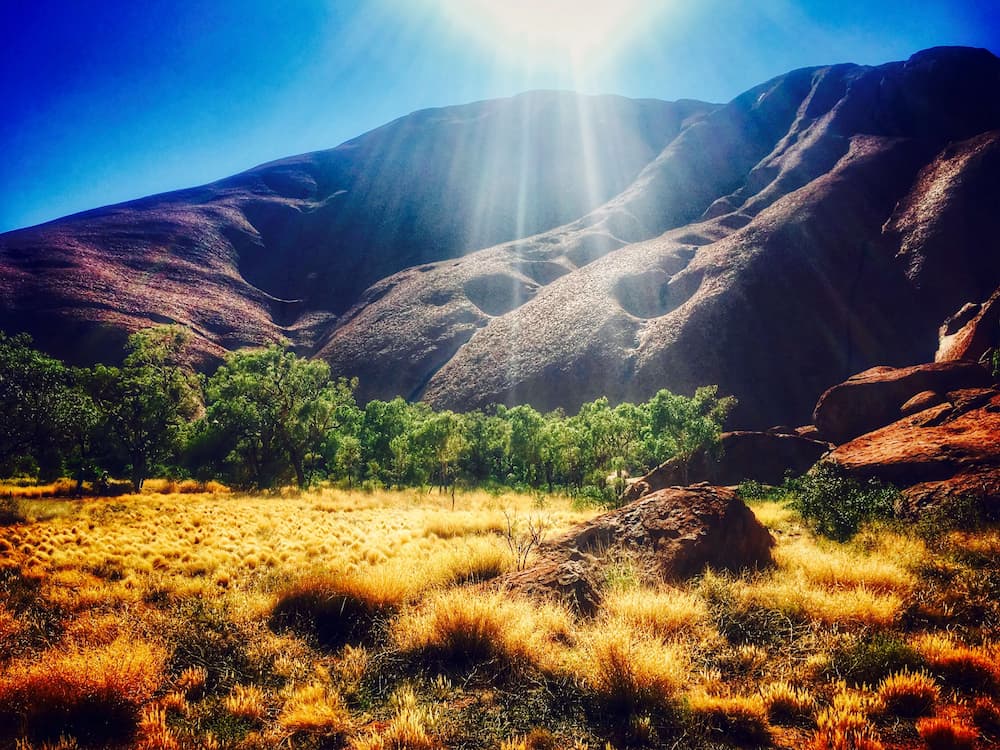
[0,326,735,494]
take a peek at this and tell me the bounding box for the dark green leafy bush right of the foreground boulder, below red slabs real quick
[787,464,899,542]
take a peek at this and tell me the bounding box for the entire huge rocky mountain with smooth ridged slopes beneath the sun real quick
[0,48,1000,426]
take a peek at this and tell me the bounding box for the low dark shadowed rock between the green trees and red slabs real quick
[622,431,833,502]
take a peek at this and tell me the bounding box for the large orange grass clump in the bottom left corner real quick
[0,639,165,742]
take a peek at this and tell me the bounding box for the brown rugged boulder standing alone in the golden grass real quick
[494,486,774,614]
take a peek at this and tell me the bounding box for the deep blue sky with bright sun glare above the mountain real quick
[0,0,1000,231]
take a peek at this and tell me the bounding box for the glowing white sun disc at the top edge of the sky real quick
[439,0,661,67]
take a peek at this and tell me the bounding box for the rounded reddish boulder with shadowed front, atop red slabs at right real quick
[813,361,992,444]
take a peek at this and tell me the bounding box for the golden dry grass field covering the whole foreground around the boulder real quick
[0,482,1000,750]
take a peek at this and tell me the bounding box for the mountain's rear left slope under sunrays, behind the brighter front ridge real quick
[0,92,704,366]
